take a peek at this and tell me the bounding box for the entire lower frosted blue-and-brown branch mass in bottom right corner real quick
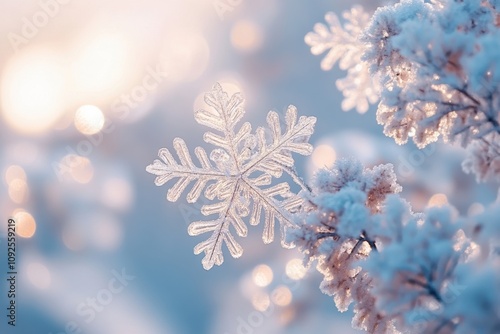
[288,160,500,334]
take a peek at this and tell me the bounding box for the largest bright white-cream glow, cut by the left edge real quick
[0,52,66,134]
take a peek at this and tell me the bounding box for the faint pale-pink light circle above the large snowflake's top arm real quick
[160,32,210,81]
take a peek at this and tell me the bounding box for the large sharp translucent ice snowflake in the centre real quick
[146,84,316,270]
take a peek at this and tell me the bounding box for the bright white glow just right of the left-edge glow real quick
[72,33,130,94]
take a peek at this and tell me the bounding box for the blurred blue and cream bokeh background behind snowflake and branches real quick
[0,0,495,334]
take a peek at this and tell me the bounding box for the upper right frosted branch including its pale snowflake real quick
[306,0,500,180]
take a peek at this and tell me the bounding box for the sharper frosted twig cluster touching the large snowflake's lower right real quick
[288,159,401,333]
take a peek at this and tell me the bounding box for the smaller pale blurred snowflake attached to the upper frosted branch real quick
[305,6,380,113]
